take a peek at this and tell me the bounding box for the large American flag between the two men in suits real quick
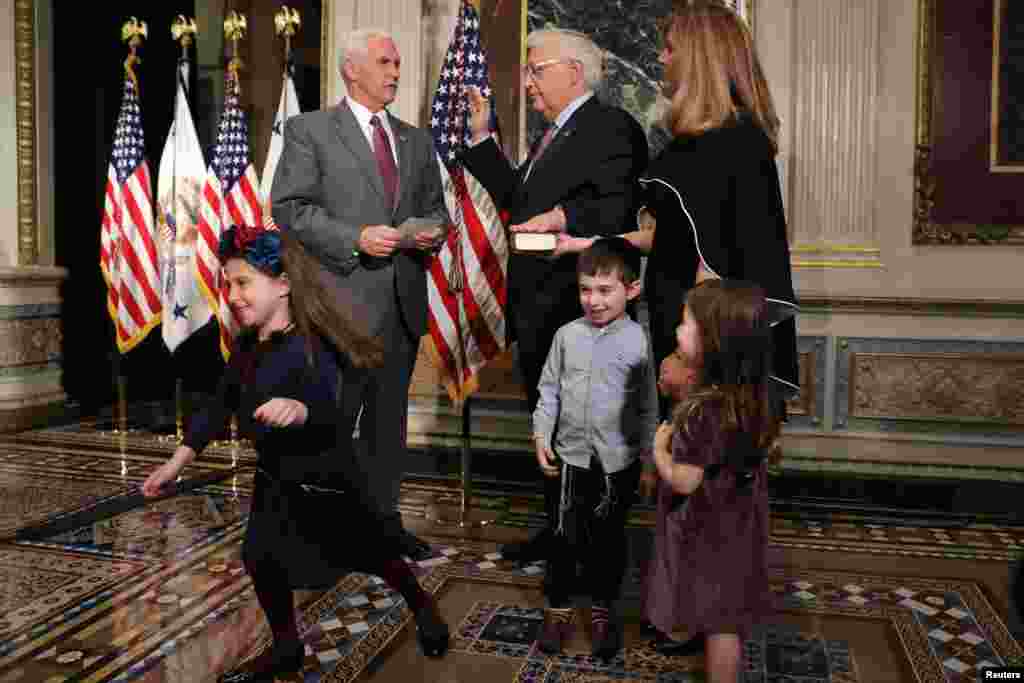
[427,0,508,402]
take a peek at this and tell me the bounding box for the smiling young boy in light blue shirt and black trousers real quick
[534,238,657,658]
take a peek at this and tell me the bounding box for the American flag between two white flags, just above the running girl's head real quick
[196,65,263,360]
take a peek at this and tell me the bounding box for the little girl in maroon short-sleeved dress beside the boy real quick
[644,280,779,683]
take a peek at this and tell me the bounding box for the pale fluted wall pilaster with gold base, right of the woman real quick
[778,0,883,268]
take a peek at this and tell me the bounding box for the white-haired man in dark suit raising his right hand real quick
[462,30,647,560]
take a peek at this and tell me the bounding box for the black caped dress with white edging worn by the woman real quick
[640,115,800,395]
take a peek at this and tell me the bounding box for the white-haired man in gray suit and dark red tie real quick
[271,30,449,559]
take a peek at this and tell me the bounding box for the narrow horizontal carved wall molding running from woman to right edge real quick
[797,292,1024,318]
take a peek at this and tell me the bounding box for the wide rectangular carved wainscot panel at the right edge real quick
[849,351,1024,426]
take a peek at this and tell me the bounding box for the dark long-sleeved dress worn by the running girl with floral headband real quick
[184,333,400,588]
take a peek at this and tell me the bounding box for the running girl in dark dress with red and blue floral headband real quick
[142,225,449,683]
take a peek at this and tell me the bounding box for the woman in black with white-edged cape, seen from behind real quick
[629,0,800,417]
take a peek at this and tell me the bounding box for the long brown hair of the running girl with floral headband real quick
[281,230,383,368]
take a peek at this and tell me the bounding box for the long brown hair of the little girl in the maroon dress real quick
[673,280,780,449]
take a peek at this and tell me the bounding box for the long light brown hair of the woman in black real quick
[662,0,779,150]
